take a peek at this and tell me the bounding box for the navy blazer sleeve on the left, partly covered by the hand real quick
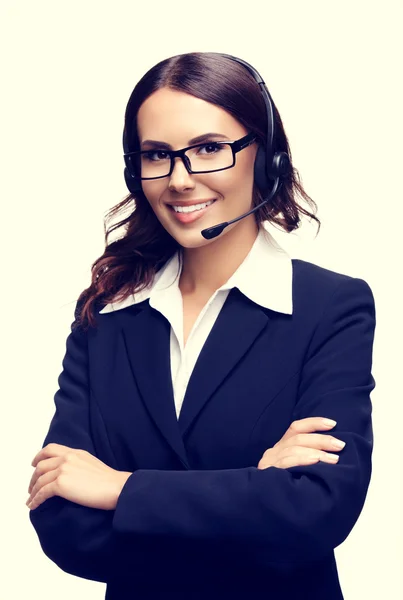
[29,303,133,582]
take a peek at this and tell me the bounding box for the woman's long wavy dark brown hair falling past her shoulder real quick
[74,52,320,326]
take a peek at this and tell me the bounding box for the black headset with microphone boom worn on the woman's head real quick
[123,52,291,239]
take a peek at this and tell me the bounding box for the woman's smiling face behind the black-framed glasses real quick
[137,88,257,248]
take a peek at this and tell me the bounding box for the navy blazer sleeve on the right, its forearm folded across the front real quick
[112,278,375,563]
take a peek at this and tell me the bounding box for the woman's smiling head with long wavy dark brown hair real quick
[68,52,320,326]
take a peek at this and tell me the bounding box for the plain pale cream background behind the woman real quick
[0,0,403,600]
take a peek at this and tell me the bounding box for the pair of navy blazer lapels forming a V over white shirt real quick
[121,288,270,469]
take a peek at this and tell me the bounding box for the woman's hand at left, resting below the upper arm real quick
[26,444,132,510]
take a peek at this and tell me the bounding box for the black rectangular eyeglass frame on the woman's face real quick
[123,132,256,180]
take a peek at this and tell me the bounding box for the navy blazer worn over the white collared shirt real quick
[29,259,375,600]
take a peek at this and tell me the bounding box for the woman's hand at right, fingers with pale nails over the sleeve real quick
[257,417,345,469]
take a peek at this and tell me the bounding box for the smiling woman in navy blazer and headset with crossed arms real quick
[28,53,375,600]
